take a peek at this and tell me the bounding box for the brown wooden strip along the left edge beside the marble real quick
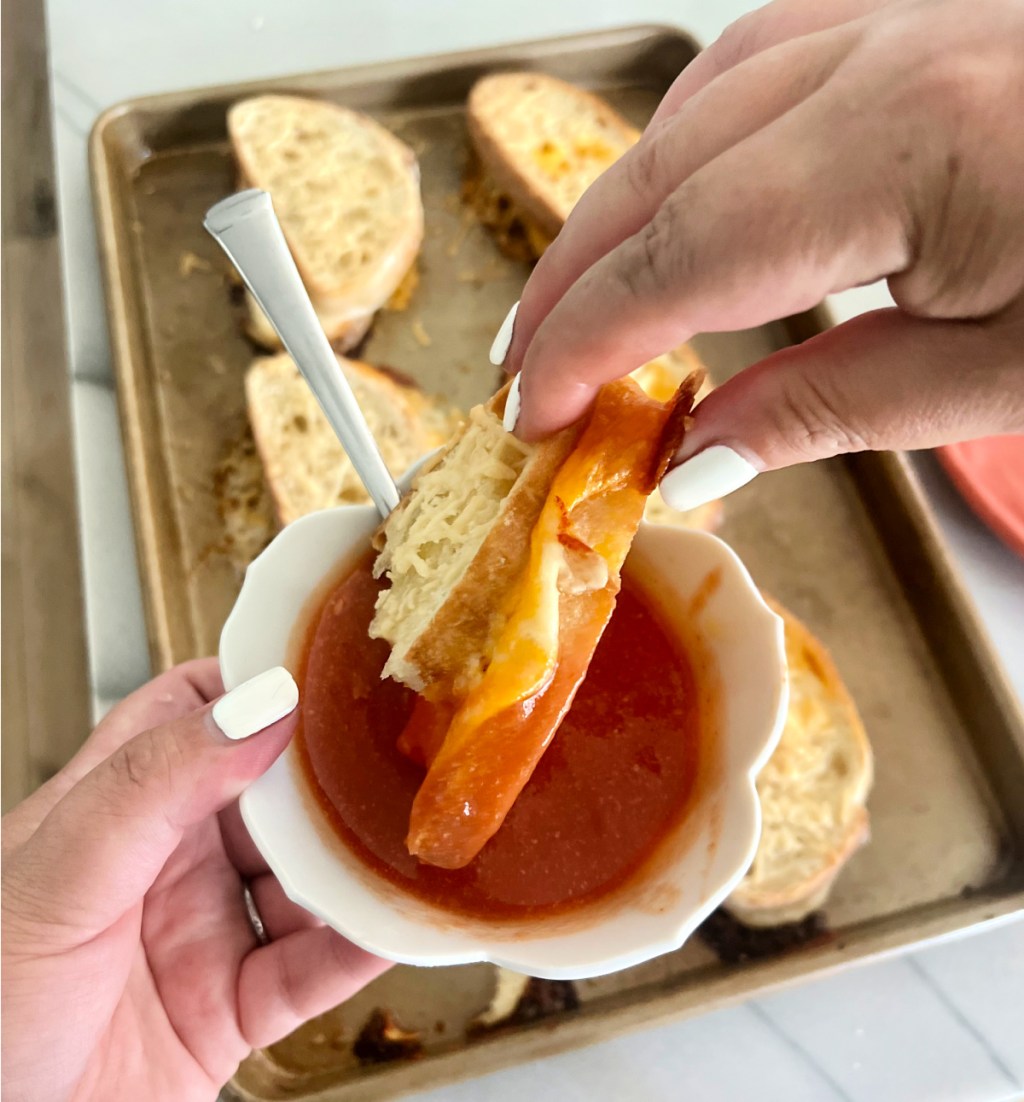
[2,0,91,810]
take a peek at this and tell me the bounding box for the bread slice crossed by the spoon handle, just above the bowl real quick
[246,353,456,525]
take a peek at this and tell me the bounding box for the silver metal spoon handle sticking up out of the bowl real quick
[203,188,399,517]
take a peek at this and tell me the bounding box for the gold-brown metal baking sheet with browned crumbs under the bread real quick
[93,28,1024,1100]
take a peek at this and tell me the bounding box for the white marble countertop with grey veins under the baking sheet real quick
[47,0,1024,1102]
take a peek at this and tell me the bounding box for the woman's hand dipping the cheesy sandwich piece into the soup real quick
[506,0,1024,506]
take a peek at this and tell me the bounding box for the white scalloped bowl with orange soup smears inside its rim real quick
[220,506,788,980]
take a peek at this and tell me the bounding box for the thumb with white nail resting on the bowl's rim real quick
[6,667,299,948]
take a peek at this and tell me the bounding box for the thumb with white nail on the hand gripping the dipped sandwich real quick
[661,307,1024,509]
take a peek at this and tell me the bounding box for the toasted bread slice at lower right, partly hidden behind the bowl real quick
[725,605,873,926]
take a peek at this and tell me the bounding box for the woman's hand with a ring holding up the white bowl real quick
[3,659,387,1102]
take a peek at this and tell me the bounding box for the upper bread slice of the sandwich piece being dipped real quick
[370,386,579,691]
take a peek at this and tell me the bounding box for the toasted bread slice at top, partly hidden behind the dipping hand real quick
[464,73,639,258]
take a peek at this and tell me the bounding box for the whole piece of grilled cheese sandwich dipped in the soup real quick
[370,378,698,868]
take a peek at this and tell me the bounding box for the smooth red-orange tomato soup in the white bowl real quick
[297,558,701,918]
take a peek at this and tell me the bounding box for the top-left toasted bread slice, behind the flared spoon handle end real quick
[227,96,423,347]
